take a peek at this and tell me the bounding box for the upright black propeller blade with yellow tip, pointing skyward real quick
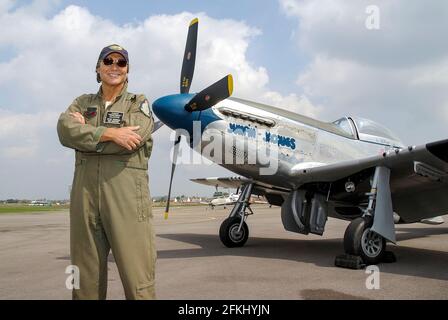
[180,18,199,93]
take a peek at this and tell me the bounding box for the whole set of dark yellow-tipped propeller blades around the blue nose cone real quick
[165,18,233,219]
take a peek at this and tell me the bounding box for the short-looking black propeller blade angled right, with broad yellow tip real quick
[185,74,233,112]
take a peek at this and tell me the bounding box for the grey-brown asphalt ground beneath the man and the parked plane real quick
[0,205,448,300]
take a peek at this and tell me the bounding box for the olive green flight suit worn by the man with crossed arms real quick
[57,87,156,299]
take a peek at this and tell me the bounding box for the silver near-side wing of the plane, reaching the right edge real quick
[291,140,448,222]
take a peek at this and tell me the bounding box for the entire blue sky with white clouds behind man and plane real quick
[0,0,448,199]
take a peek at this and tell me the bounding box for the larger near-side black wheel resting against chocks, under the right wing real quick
[344,217,386,265]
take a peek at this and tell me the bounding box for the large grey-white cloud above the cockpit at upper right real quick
[280,0,448,144]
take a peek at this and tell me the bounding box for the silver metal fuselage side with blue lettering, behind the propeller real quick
[200,98,402,189]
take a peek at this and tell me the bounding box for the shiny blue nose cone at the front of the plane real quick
[152,94,194,130]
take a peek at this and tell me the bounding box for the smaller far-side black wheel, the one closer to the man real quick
[219,217,249,248]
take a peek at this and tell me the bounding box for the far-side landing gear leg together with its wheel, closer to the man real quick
[219,184,254,248]
